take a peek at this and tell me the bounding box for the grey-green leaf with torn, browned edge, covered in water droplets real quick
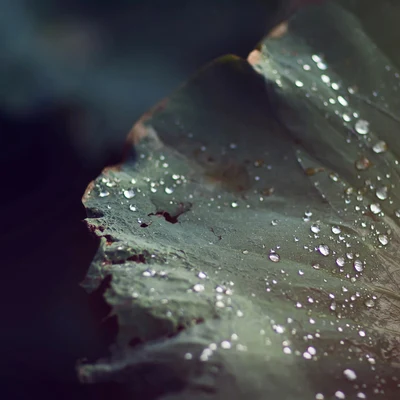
[79,5,400,399]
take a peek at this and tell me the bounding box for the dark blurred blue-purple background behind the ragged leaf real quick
[0,0,400,398]
